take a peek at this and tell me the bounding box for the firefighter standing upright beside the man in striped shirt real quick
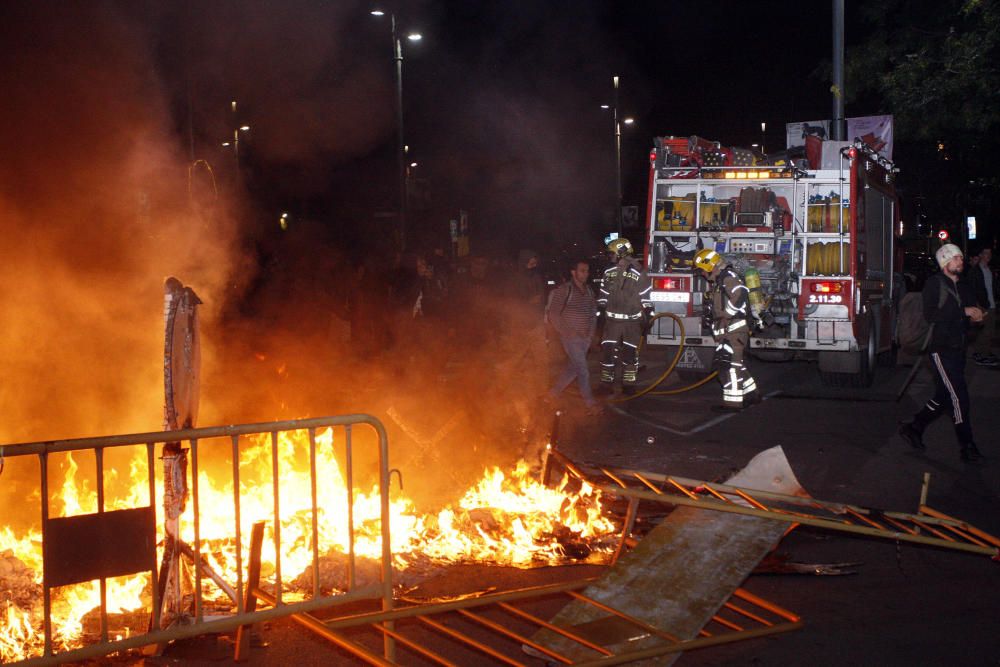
[595,238,653,396]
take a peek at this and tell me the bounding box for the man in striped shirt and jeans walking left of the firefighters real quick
[545,260,601,414]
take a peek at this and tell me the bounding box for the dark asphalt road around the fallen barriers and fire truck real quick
[153,344,1000,665]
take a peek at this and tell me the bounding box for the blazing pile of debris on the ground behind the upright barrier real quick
[0,430,617,661]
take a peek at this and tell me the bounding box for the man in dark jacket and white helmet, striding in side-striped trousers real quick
[899,243,983,462]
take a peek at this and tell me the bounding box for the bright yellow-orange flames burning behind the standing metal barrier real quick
[0,429,615,662]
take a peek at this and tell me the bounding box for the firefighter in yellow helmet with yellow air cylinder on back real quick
[694,248,760,410]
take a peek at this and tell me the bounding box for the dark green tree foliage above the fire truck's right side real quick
[846,0,1000,236]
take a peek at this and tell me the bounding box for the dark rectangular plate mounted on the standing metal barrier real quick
[43,507,156,588]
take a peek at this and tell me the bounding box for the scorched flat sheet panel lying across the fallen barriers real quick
[533,447,805,665]
